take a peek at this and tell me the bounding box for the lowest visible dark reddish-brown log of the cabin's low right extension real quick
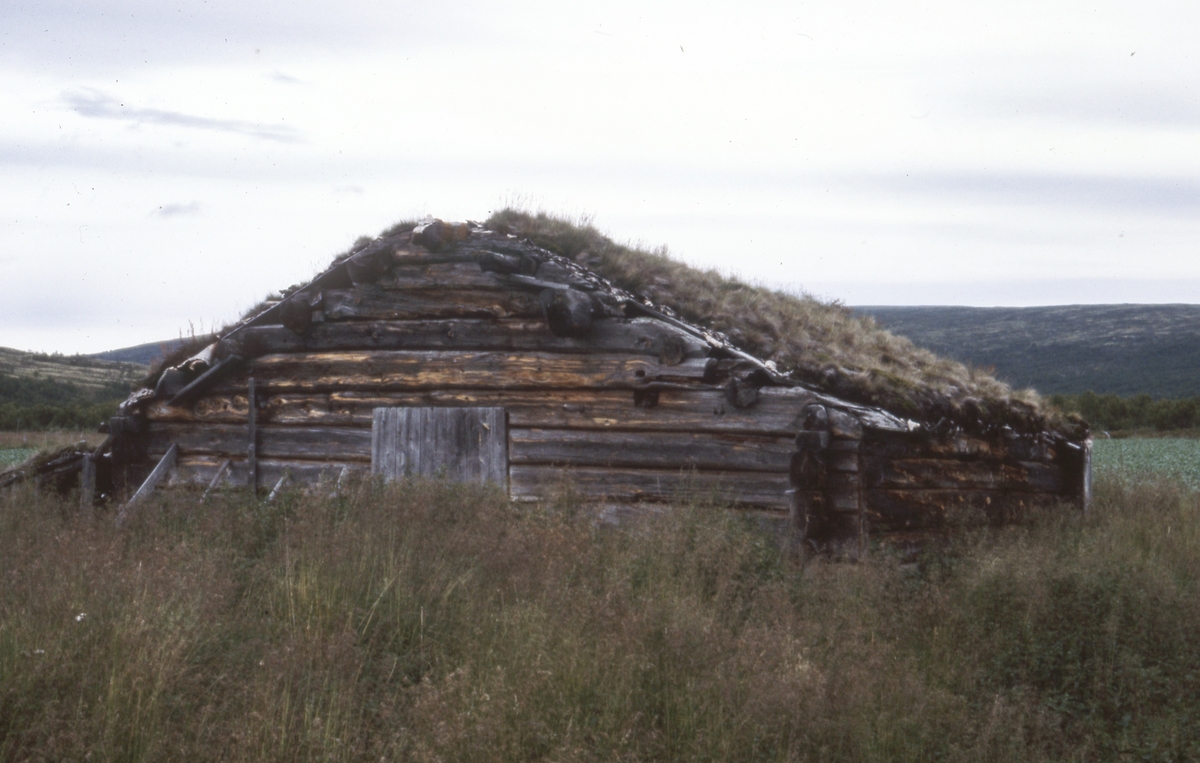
[864,489,1063,533]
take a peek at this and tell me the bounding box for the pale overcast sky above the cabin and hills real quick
[0,0,1200,353]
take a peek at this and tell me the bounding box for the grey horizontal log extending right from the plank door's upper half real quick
[509,428,796,474]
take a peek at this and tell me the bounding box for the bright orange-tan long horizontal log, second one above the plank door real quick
[212,350,716,393]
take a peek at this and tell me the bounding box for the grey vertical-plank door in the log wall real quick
[371,408,509,486]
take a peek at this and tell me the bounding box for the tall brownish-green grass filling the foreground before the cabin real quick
[0,480,1200,761]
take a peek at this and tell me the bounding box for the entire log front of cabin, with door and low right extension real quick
[98,221,1090,554]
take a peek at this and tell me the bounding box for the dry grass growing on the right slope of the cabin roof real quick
[486,209,1086,437]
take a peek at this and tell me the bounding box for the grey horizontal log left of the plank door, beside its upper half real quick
[146,423,371,463]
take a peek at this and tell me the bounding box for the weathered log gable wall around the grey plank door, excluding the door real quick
[142,250,811,515]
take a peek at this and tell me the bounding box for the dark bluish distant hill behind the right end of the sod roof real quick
[853,305,1200,398]
